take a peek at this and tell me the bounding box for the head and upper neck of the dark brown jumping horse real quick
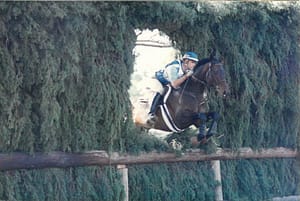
[192,58,229,97]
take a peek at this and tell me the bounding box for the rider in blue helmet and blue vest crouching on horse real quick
[147,52,198,124]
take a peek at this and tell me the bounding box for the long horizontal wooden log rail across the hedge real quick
[0,147,299,171]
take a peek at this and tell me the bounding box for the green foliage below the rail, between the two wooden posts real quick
[129,162,216,201]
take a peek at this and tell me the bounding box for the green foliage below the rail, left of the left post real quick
[0,167,125,201]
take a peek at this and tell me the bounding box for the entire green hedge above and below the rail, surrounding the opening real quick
[0,2,300,201]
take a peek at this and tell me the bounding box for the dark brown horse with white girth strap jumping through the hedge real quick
[132,57,229,144]
